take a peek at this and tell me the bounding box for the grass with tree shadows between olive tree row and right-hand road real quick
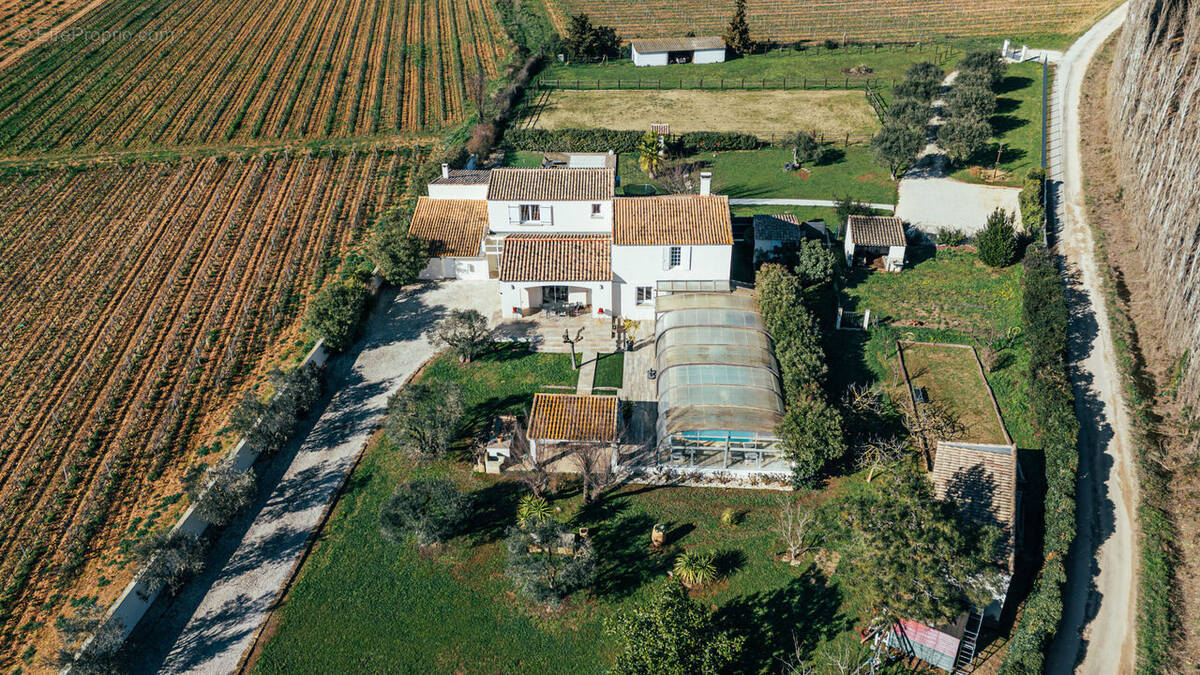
[953,62,1042,185]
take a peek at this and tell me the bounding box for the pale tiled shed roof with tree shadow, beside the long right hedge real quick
[930,441,1016,566]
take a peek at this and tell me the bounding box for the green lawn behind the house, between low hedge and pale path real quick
[620,145,896,200]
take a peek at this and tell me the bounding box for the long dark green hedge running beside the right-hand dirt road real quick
[1000,244,1079,675]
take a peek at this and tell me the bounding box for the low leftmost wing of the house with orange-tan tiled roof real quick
[408,197,488,279]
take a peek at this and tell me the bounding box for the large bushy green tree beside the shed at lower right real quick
[840,468,1002,625]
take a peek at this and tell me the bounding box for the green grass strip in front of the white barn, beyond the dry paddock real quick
[542,46,961,88]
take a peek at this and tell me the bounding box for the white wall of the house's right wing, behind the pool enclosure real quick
[612,246,733,319]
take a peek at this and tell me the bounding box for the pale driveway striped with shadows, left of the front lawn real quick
[127,281,496,674]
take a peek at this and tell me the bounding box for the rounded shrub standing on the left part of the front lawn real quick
[379,478,472,546]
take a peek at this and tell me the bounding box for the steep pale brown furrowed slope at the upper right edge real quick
[1109,0,1200,405]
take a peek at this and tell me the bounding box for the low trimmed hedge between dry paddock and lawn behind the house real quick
[504,129,762,155]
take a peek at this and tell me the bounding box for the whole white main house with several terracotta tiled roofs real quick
[410,163,733,319]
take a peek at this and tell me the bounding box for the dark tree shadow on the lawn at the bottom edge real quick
[716,567,851,673]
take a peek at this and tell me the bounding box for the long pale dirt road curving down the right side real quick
[1046,5,1138,675]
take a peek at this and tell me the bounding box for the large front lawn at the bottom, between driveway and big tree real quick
[254,341,900,674]
